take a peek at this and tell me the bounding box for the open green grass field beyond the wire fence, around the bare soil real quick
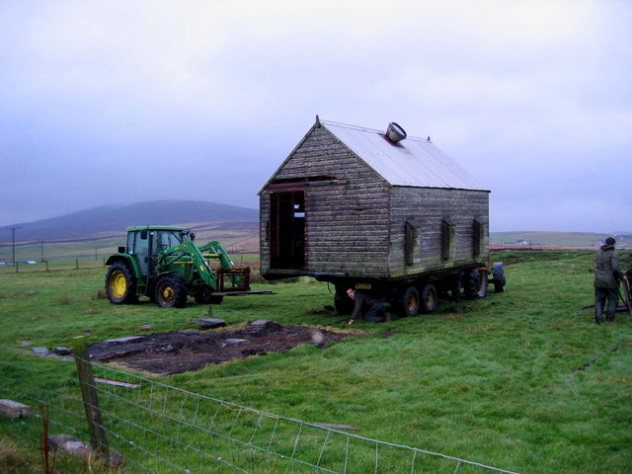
[0,251,632,473]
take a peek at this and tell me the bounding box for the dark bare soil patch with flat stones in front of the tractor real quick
[88,321,353,375]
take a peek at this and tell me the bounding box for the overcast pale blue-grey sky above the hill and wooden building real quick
[0,0,632,232]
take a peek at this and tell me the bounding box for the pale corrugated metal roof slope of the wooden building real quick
[320,120,486,190]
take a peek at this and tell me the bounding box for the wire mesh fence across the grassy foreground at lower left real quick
[0,348,511,474]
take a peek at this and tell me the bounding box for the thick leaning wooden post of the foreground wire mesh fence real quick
[72,337,109,462]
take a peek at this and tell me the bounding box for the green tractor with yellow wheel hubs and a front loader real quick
[105,226,250,308]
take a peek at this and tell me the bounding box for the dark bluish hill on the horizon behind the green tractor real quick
[7,201,259,242]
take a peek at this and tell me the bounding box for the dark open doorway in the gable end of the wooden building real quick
[270,191,305,269]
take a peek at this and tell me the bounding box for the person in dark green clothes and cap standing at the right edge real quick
[595,237,623,324]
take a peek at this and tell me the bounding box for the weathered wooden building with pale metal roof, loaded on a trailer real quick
[259,117,489,312]
